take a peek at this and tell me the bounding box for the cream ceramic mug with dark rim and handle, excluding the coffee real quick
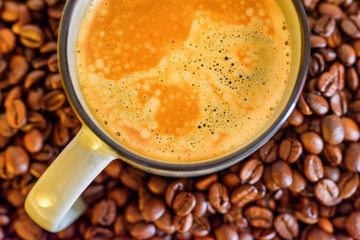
[25,0,310,232]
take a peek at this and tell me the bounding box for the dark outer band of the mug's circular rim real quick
[58,0,310,177]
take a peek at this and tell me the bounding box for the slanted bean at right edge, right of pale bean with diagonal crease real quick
[337,172,359,199]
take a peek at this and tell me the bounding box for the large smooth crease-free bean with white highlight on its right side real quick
[321,114,344,145]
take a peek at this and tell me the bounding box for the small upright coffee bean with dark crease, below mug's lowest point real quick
[173,192,196,216]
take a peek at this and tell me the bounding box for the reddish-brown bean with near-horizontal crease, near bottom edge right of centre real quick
[245,206,273,228]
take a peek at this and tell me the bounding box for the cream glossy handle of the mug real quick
[25,126,117,232]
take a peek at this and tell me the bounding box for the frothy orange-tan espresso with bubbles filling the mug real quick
[77,0,292,162]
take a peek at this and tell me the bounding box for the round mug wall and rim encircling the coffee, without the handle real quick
[59,0,310,176]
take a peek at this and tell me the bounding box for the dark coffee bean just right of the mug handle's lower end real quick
[91,200,116,226]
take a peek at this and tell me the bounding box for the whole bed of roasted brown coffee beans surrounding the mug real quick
[0,0,360,240]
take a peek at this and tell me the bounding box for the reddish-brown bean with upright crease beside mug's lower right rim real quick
[279,138,303,164]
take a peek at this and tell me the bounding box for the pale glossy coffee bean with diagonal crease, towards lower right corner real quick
[314,179,339,206]
